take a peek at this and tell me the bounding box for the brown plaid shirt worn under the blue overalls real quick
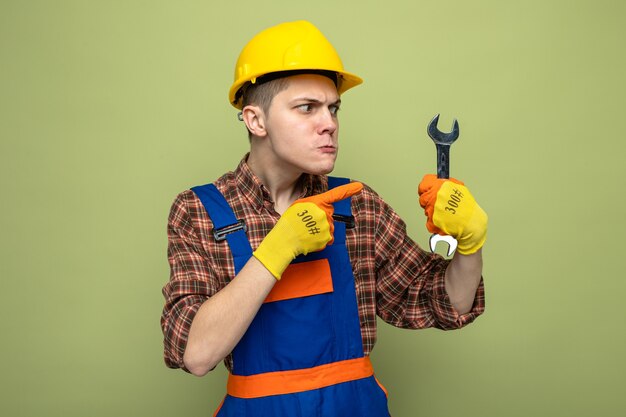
[161,158,485,370]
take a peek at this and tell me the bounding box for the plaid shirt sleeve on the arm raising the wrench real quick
[374,188,485,330]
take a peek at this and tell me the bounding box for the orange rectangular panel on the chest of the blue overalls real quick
[265,259,333,303]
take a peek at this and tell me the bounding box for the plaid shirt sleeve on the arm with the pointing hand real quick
[161,191,217,372]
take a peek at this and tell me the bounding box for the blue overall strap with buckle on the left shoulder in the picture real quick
[191,184,252,273]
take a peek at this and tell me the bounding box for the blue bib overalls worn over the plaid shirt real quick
[192,177,389,417]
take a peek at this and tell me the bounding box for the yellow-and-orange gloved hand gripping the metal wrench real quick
[418,174,487,255]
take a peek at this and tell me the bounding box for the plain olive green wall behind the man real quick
[0,0,626,417]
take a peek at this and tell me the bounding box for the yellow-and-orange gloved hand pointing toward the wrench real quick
[253,182,363,279]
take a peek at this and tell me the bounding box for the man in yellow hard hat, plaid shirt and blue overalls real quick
[162,21,487,417]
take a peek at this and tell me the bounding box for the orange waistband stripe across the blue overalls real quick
[226,356,374,398]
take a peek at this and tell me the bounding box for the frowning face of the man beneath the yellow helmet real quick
[262,74,340,175]
